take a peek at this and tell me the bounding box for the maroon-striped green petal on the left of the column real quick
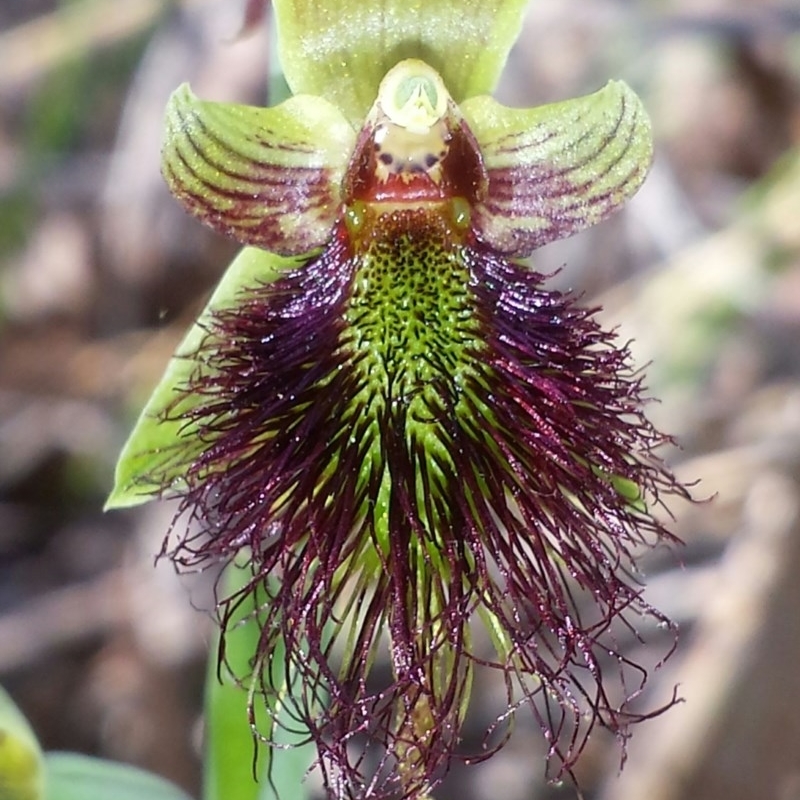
[162,84,355,255]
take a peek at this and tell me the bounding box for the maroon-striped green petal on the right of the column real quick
[462,81,653,257]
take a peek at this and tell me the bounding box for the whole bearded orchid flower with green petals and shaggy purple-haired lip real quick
[108,0,685,797]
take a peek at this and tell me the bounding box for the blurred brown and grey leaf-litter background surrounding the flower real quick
[0,0,800,800]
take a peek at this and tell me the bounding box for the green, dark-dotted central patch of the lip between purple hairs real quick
[346,201,482,482]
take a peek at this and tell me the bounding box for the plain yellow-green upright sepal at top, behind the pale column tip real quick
[273,0,527,126]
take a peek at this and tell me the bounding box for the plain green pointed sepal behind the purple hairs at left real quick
[105,248,297,511]
